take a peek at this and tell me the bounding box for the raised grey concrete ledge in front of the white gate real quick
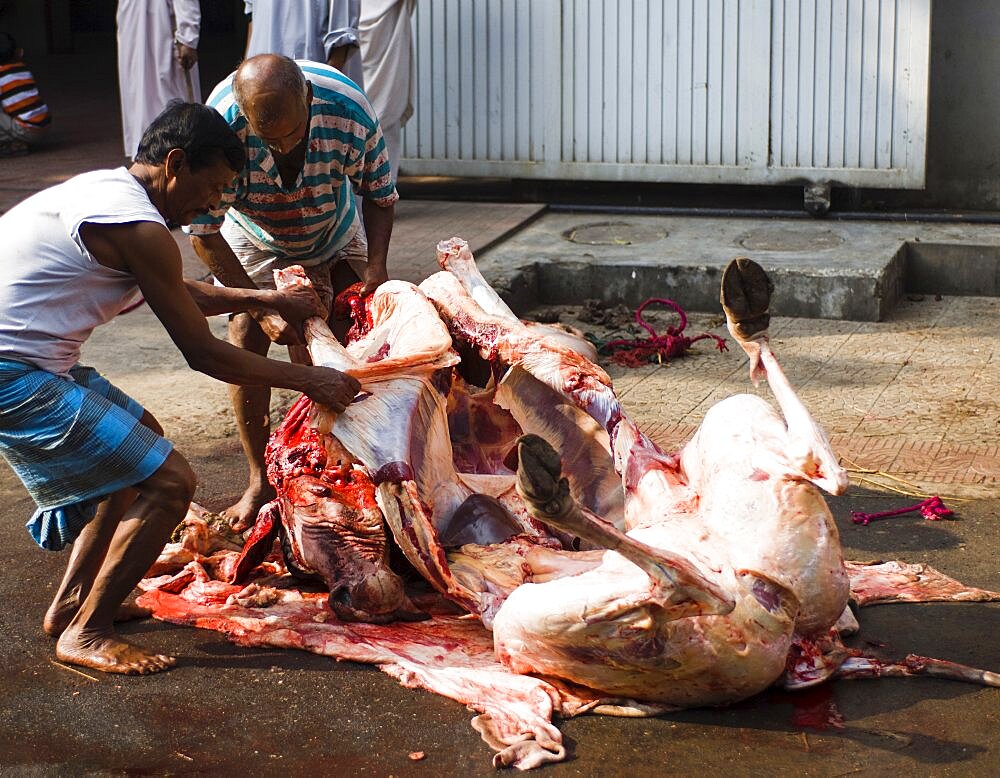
[478,213,1000,321]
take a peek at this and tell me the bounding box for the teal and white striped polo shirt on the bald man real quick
[186,60,399,265]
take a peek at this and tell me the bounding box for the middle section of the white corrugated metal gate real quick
[561,0,769,166]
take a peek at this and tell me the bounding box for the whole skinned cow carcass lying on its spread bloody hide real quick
[143,239,1000,769]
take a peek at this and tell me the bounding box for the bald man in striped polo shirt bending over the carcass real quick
[187,54,398,529]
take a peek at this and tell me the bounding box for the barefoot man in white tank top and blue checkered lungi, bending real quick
[0,103,358,673]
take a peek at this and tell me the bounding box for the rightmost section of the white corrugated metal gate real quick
[771,0,930,177]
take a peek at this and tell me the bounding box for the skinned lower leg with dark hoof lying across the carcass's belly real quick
[517,435,735,615]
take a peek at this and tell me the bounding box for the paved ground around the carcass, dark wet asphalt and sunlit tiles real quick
[0,31,1000,776]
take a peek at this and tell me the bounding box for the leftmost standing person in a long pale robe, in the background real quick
[116,0,201,159]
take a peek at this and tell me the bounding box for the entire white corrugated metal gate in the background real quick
[403,0,930,187]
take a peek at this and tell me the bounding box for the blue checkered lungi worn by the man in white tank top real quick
[0,359,173,551]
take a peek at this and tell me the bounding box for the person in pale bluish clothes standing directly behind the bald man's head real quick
[243,0,365,89]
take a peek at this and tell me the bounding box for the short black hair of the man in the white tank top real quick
[135,100,246,173]
